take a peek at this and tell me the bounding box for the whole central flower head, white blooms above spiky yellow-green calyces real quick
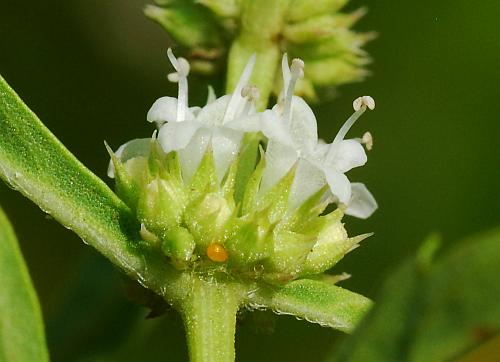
[108,49,377,283]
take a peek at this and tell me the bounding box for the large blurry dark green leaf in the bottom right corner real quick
[332,230,500,362]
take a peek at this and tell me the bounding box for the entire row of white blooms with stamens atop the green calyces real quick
[108,49,378,218]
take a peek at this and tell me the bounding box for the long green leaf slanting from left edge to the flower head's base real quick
[0,73,183,298]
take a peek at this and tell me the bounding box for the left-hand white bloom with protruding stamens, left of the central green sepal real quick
[148,49,258,180]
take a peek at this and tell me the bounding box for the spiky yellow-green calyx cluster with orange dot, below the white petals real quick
[108,134,366,284]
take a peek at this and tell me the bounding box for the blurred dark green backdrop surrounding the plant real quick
[0,0,500,361]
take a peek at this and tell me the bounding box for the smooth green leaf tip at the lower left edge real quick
[0,208,49,362]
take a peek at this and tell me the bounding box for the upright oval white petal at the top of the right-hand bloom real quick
[290,96,318,154]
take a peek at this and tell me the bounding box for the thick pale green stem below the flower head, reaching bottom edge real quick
[180,277,243,362]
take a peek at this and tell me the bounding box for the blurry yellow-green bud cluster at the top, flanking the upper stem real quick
[145,0,374,99]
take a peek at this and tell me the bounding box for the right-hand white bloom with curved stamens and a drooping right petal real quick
[262,55,377,218]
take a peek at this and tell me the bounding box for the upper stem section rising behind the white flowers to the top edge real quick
[226,0,286,109]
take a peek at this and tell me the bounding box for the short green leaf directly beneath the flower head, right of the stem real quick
[249,279,372,333]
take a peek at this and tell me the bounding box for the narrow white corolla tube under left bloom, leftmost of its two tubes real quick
[179,128,211,183]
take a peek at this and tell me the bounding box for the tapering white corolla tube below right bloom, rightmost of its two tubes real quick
[289,159,326,210]
